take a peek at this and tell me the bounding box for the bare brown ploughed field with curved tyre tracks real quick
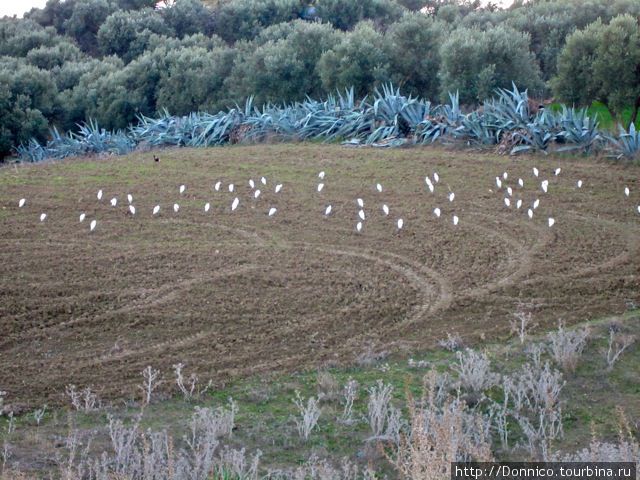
[0,145,640,407]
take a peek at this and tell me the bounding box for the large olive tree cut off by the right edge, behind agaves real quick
[552,15,640,127]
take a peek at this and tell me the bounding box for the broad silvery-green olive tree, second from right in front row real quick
[439,25,544,104]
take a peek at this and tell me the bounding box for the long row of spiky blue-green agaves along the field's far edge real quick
[16,85,640,162]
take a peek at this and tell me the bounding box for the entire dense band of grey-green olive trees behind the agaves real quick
[0,0,640,158]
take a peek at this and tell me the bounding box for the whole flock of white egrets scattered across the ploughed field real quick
[12,163,640,233]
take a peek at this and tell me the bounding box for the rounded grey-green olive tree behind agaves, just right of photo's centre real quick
[318,22,390,96]
